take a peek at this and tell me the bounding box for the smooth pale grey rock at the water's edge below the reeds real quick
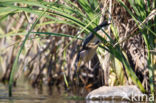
[86,85,143,100]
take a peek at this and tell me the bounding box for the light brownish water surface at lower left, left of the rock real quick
[0,82,129,103]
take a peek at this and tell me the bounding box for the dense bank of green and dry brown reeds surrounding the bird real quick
[0,0,156,95]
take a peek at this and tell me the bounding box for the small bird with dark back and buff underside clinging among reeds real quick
[74,21,110,72]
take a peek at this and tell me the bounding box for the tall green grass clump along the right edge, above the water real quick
[118,0,156,94]
